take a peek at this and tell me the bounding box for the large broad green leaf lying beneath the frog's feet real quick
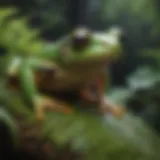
[42,112,160,160]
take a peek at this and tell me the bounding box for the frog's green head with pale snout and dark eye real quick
[58,28,121,65]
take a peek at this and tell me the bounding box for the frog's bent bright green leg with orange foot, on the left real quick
[20,59,73,120]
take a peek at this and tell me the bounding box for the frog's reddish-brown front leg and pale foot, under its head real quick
[80,73,126,117]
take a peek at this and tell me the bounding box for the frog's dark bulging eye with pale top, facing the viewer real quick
[71,28,91,49]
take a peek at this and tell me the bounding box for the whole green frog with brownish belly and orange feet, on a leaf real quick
[8,27,124,120]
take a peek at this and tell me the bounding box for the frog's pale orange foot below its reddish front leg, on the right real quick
[100,98,126,118]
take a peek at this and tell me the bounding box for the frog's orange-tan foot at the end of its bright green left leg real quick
[35,97,73,121]
